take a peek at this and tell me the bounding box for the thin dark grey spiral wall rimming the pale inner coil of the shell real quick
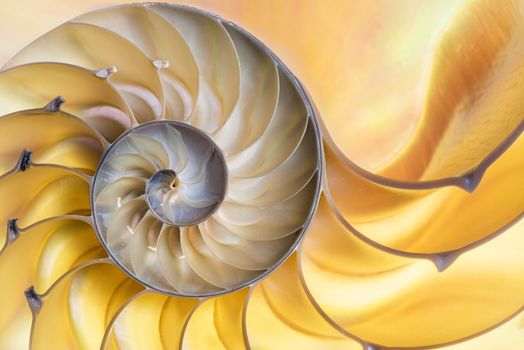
[84,2,324,299]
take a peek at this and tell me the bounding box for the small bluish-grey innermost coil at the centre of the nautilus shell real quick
[94,121,227,226]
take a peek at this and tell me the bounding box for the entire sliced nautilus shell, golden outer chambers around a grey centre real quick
[0,1,524,350]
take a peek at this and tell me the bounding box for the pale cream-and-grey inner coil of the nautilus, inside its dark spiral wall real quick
[64,5,322,297]
